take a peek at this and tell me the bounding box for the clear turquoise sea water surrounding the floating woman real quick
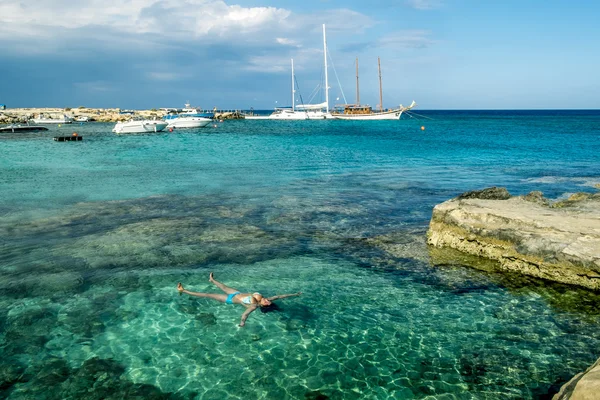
[0,111,600,399]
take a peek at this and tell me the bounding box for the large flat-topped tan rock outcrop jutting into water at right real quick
[427,188,600,290]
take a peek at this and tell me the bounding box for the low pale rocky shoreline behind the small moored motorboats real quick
[0,107,243,125]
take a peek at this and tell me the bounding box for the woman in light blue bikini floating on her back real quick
[177,272,302,326]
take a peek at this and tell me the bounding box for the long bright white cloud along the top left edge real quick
[0,0,291,37]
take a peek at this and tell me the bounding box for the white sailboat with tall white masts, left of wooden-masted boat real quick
[245,24,332,120]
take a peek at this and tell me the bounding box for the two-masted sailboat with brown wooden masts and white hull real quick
[331,57,417,121]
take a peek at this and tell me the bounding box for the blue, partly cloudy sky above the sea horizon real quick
[0,0,600,110]
